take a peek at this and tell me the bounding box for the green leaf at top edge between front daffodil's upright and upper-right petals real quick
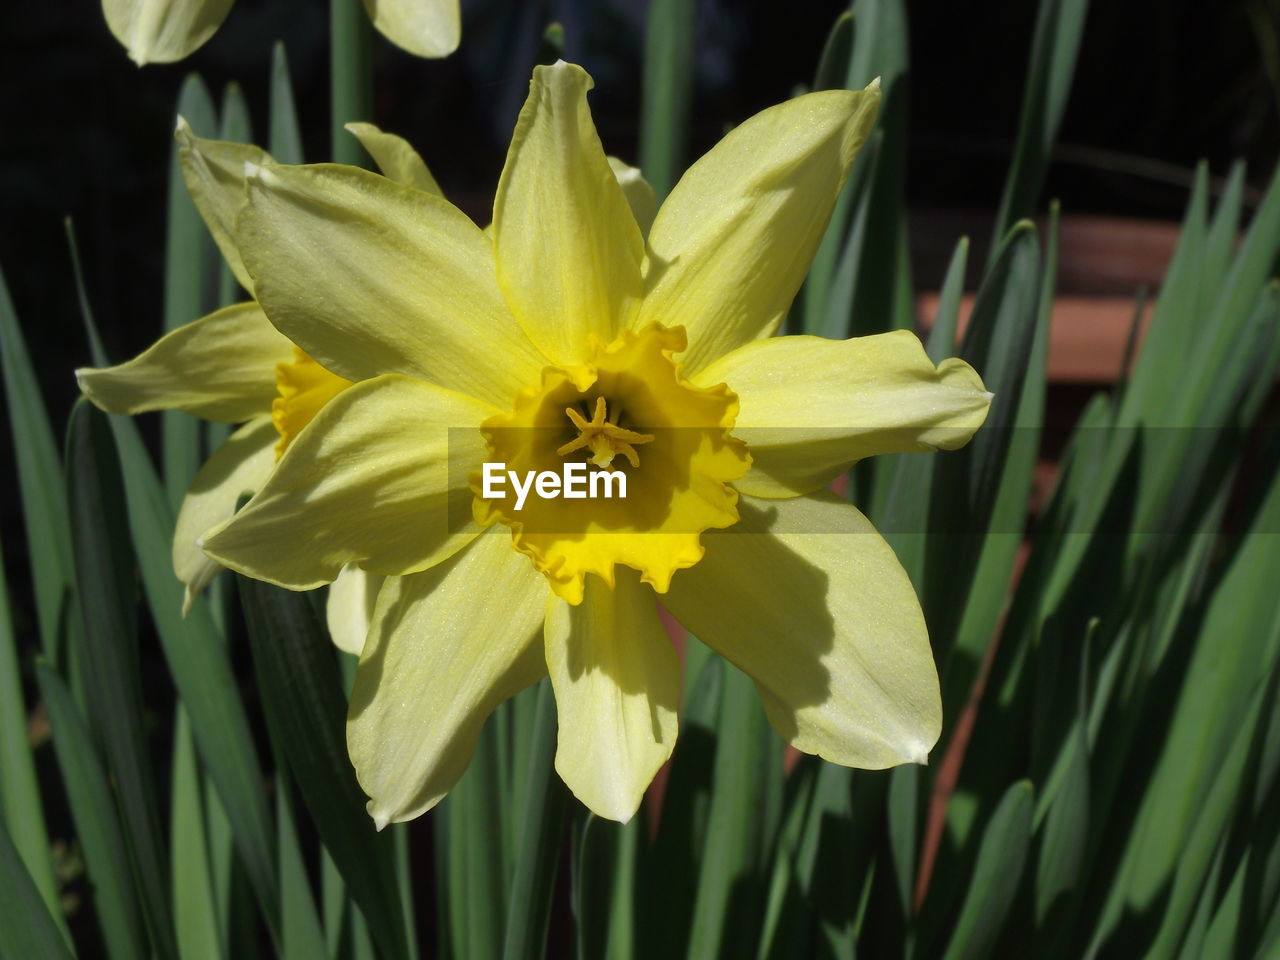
[640,0,696,204]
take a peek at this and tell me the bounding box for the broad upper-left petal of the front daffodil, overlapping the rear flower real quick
[237,164,545,407]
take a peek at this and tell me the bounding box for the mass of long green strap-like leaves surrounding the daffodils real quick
[0,0,1280,960]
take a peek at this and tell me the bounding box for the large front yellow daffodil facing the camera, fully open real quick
[194,63,991,827]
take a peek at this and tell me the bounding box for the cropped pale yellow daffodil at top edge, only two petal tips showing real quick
[102,0,462,67]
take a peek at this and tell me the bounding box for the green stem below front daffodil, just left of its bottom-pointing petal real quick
[502,680,568,960]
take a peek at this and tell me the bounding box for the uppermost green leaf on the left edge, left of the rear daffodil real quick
[0,264,74,663]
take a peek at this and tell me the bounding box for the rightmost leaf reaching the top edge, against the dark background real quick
[991,0,1089,245]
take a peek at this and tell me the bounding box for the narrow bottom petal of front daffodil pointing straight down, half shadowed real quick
[545,570,680,822]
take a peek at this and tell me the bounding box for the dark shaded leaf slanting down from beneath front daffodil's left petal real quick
[237,577,408,957]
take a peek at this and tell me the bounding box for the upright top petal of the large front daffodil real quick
[493,61,644,364]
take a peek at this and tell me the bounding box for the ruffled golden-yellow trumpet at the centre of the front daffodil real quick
[471,324,751,604]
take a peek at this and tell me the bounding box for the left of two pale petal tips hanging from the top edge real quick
[102,0,232,67]
